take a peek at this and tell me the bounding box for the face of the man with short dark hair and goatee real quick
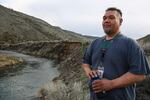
[102,11,122,35]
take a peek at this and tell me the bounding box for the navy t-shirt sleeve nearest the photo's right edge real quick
[128,40,150,74]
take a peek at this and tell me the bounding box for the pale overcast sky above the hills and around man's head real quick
[0,0,150,39]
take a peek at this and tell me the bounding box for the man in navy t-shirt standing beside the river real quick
[82,7,150,100]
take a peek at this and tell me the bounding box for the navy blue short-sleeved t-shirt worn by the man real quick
[83,34,150,100]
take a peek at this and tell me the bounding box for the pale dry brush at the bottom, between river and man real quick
[38,81,89,100]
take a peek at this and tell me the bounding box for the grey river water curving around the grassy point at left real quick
[0,50,59,100]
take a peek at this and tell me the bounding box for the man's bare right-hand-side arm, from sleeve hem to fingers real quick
[93,72,145,93]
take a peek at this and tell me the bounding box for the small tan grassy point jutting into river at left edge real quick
[0,53,23,71]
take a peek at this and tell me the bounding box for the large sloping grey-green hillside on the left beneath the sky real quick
[0,5,88,44]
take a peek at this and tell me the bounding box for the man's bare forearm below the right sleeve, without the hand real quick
[112,72,145,88]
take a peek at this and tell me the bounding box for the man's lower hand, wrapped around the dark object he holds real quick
[92,79,113,93]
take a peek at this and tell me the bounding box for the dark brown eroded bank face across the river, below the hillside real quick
[0,41,82,61]
